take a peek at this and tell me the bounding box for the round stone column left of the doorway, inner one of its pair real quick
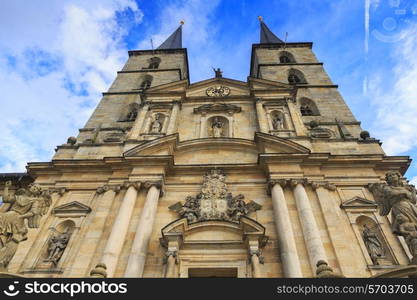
[125,183,161,277]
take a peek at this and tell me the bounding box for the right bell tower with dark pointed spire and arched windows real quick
[250,17,361,140]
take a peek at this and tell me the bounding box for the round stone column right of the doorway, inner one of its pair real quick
[271,180,302,278]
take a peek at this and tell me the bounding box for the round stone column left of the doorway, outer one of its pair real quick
[101,182,140,277]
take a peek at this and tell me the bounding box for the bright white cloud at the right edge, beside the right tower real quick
[369,24,417,155]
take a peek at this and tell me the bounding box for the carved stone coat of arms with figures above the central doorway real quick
[169,169,262,224]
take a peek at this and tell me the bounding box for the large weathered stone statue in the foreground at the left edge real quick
[0,181,51,271]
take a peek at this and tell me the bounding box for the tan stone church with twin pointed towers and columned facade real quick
[0,18,417,278]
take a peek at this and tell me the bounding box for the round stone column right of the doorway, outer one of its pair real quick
[290,180,327,271]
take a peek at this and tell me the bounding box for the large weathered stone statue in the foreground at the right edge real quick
[369,172,417,264]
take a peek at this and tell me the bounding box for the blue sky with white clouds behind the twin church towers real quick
[0,0,417,183]
